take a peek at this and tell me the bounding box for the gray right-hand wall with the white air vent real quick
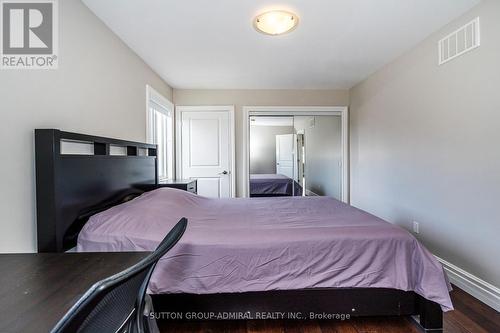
[351,0,500,286]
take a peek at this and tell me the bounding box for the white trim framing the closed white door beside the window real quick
[175,105,236,197]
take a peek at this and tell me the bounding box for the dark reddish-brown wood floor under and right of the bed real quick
[158,286,500,333]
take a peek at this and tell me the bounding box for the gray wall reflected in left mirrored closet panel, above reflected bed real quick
[250,126,293,174]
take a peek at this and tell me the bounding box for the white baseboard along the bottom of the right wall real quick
[436,256,500,312]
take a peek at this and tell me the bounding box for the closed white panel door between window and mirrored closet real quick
[177,107,233,198]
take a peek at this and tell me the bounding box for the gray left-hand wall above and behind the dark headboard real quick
[0,0,172,252]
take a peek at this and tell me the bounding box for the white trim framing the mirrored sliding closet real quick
[242,106,350,203]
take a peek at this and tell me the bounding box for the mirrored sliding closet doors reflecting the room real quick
[249,115,342,200]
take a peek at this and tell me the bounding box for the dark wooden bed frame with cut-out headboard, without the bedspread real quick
[35,129,443,331]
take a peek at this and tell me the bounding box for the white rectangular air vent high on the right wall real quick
[439,17,480,65]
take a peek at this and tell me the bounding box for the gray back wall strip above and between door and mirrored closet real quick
[174,89,349,196]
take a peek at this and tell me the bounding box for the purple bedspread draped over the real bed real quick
[77,188,453,311]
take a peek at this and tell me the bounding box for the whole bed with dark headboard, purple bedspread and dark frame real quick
[35,129,452,329]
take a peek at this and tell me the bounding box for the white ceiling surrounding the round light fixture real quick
[82,0,480,89]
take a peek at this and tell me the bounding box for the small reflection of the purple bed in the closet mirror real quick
[250,174,302,197]
